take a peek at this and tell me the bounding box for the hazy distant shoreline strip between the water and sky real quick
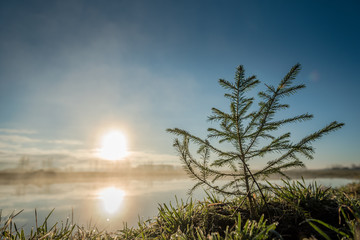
[0,168,360,185]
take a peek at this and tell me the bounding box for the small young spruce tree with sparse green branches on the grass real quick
[167,64,344,214]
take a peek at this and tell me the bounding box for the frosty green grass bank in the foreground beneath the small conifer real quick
[0,181,360,240]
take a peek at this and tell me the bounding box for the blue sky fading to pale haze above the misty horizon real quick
[0,0,360,169]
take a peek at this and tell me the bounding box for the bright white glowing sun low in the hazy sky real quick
[99,130,127,160]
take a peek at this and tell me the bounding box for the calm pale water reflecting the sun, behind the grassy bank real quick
[0,178,354,231]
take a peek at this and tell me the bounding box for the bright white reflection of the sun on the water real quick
[99,187,125,214]
